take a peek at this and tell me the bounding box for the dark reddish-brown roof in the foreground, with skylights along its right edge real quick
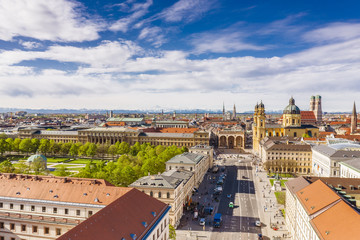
[58,189,168,240]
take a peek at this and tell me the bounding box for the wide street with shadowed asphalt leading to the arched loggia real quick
[177,154,261,240]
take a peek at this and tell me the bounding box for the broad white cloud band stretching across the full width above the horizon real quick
[0,36,360,111]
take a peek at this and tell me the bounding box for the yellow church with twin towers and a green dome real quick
[253,97,319,153]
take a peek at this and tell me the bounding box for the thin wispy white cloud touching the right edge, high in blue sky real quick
[303,22,360,43]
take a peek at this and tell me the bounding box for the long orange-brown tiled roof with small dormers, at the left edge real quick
[0,173,131,205]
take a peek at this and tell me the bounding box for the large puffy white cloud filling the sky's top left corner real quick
[0,0,102,42]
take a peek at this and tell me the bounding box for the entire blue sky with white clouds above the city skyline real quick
[0,0,360,112]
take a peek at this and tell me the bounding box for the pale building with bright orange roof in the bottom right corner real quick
[285,177,360,240]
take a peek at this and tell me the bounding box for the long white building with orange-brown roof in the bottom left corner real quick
[0,173,168,240]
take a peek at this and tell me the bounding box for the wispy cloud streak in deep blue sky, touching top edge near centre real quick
[159,0,215,22]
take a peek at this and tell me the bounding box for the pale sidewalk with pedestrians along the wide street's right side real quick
[253,160,287,240]
